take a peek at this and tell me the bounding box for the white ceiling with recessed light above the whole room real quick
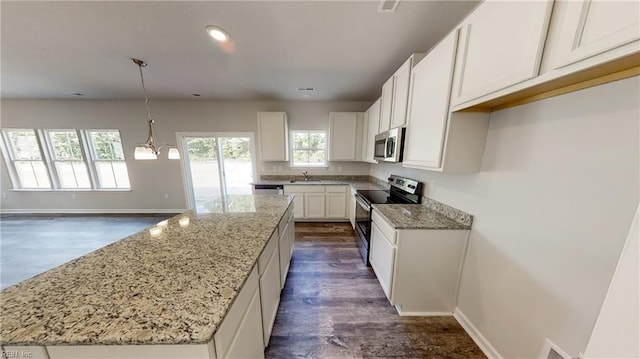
[0,0,478,101]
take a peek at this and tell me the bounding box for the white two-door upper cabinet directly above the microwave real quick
[378,54,424,132]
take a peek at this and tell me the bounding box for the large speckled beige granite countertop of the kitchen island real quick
[0,195,292,345]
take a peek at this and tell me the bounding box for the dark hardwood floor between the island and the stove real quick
[265,223,486,358]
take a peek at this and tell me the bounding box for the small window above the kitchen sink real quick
[291,131,327,167]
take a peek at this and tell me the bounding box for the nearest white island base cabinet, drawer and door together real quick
[213,266,264,358]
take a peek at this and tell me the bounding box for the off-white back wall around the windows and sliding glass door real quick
[0,100,370,212]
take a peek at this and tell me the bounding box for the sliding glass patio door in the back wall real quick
[178,133,255,212]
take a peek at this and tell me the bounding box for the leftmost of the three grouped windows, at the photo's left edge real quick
[2,130,51,189]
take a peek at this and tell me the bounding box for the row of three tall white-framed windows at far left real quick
[0,129,131,190]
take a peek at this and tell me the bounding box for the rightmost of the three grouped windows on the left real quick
[87,130,131,188]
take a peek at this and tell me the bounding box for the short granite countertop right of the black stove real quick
[373,204,471,230]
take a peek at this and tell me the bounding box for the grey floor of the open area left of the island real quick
[0,215,170,289]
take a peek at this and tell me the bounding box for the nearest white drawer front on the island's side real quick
[213,267,262,358]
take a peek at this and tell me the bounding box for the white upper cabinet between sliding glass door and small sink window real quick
[258,112,289,161]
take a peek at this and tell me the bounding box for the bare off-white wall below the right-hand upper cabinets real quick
[371,77,640,358]
